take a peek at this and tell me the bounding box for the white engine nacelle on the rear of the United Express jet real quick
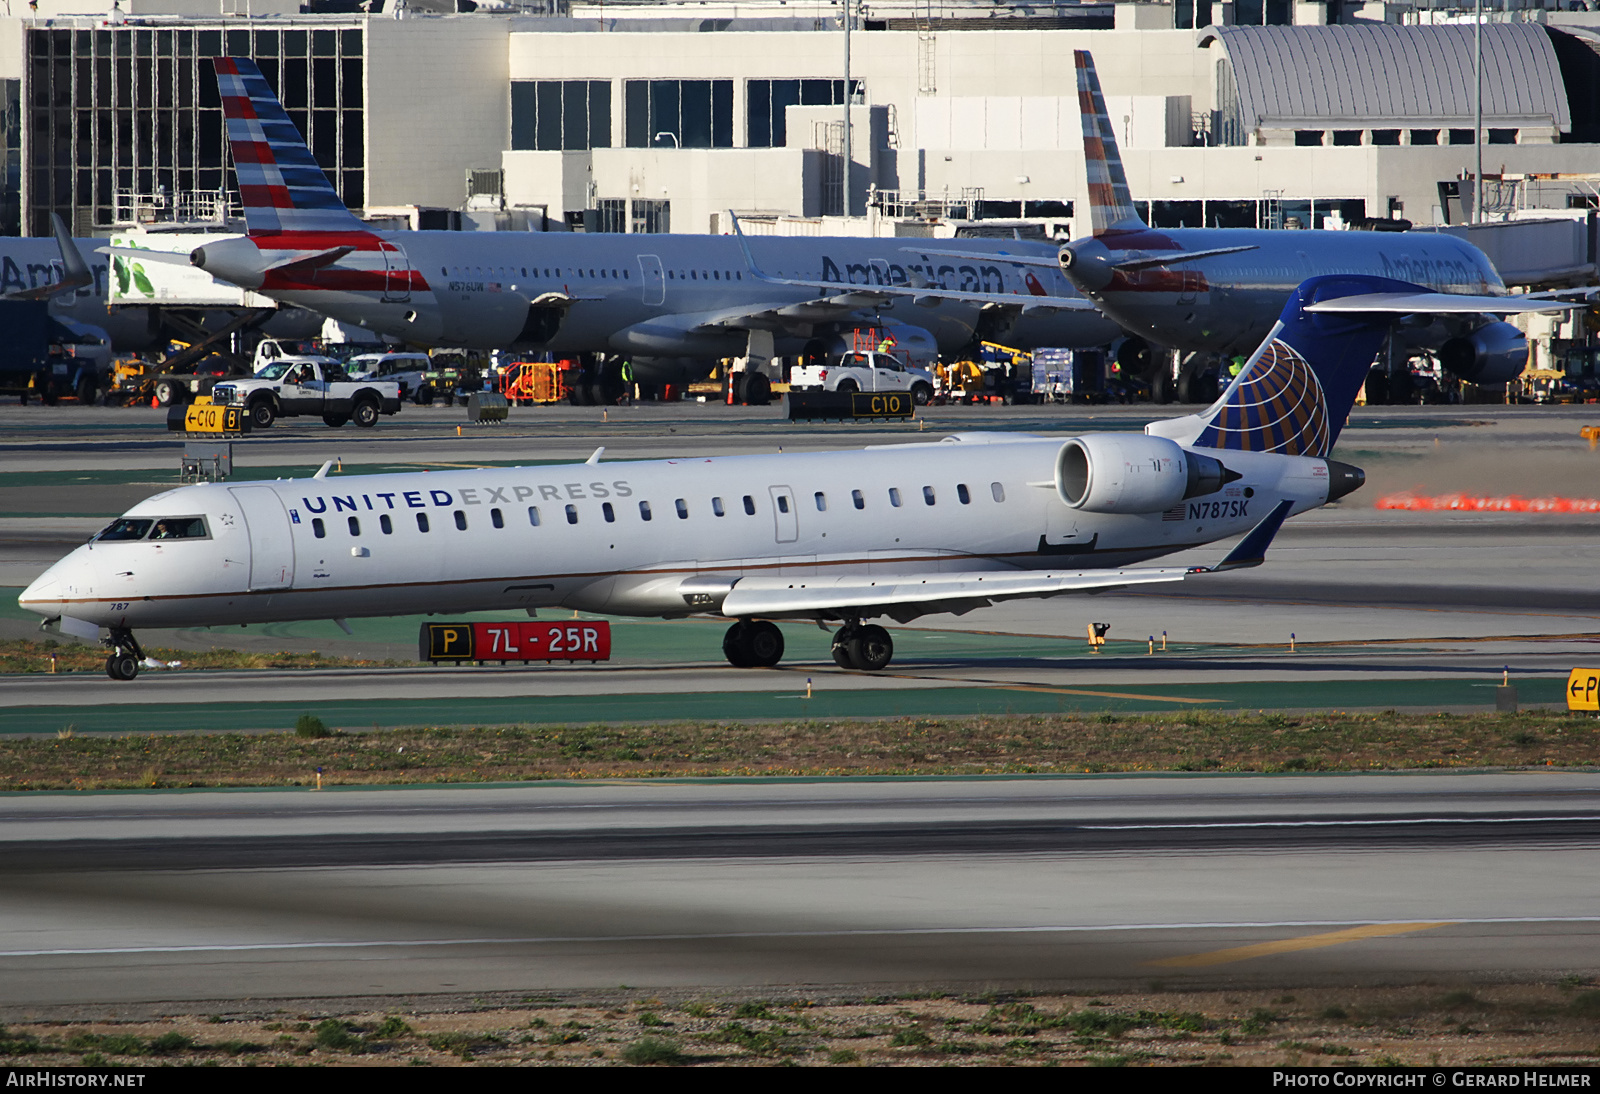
[1056,433,1240,513]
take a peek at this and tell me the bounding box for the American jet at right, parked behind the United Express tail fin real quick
[921,50,1563,393]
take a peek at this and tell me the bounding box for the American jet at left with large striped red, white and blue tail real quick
[175,58,1120,382]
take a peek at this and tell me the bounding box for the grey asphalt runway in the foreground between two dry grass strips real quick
[0,773,1600,1020]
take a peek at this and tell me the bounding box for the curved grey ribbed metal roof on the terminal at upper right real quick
[1200,22,1571,131]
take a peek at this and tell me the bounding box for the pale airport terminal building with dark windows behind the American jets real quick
[0,0,1600,260]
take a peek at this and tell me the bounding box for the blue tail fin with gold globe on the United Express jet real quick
[1184,274,1419,456]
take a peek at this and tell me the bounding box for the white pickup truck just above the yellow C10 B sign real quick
[211,357,400,429]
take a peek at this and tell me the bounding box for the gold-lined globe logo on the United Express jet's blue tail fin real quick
[1195,339,1333,456]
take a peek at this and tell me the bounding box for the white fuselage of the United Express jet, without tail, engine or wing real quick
[19,435,1328,629]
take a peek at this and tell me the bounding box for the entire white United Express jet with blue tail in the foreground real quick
[28,277,1419,680]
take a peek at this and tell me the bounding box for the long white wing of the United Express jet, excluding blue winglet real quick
[722,568,1189,622]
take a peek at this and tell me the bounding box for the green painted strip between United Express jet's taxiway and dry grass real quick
[0,669,1565,734]
